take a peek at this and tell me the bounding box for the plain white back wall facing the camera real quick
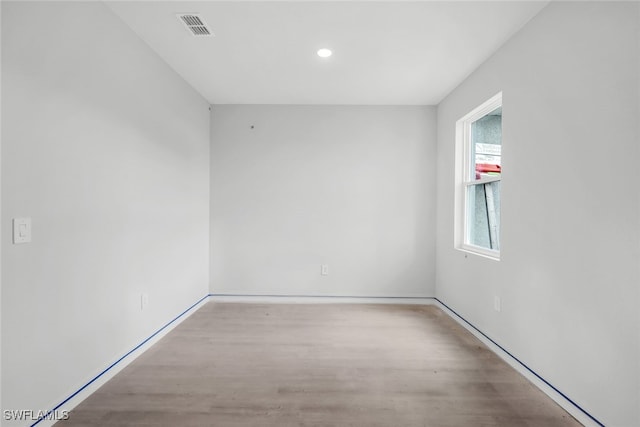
[211,106,435,297]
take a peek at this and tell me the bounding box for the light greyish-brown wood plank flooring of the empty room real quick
[56,302,580,427]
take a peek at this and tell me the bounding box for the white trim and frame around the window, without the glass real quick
[454,92,502,261]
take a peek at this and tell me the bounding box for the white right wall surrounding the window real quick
[436,2,640,427]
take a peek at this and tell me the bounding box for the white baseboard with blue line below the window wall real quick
[434,298,604,427]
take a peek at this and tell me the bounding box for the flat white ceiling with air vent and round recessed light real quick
[107,1,548,105]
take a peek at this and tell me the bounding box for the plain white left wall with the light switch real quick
[2,2,209,422]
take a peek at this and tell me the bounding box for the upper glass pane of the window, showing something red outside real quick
[470,107,502,179]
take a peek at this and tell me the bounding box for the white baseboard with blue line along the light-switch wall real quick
[31,295,209,427]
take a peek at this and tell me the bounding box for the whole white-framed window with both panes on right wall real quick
[455,93,502,259]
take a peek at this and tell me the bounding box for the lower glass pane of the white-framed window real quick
[466,181,500,251]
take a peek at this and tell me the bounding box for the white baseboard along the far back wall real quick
[210,294,436,305]
